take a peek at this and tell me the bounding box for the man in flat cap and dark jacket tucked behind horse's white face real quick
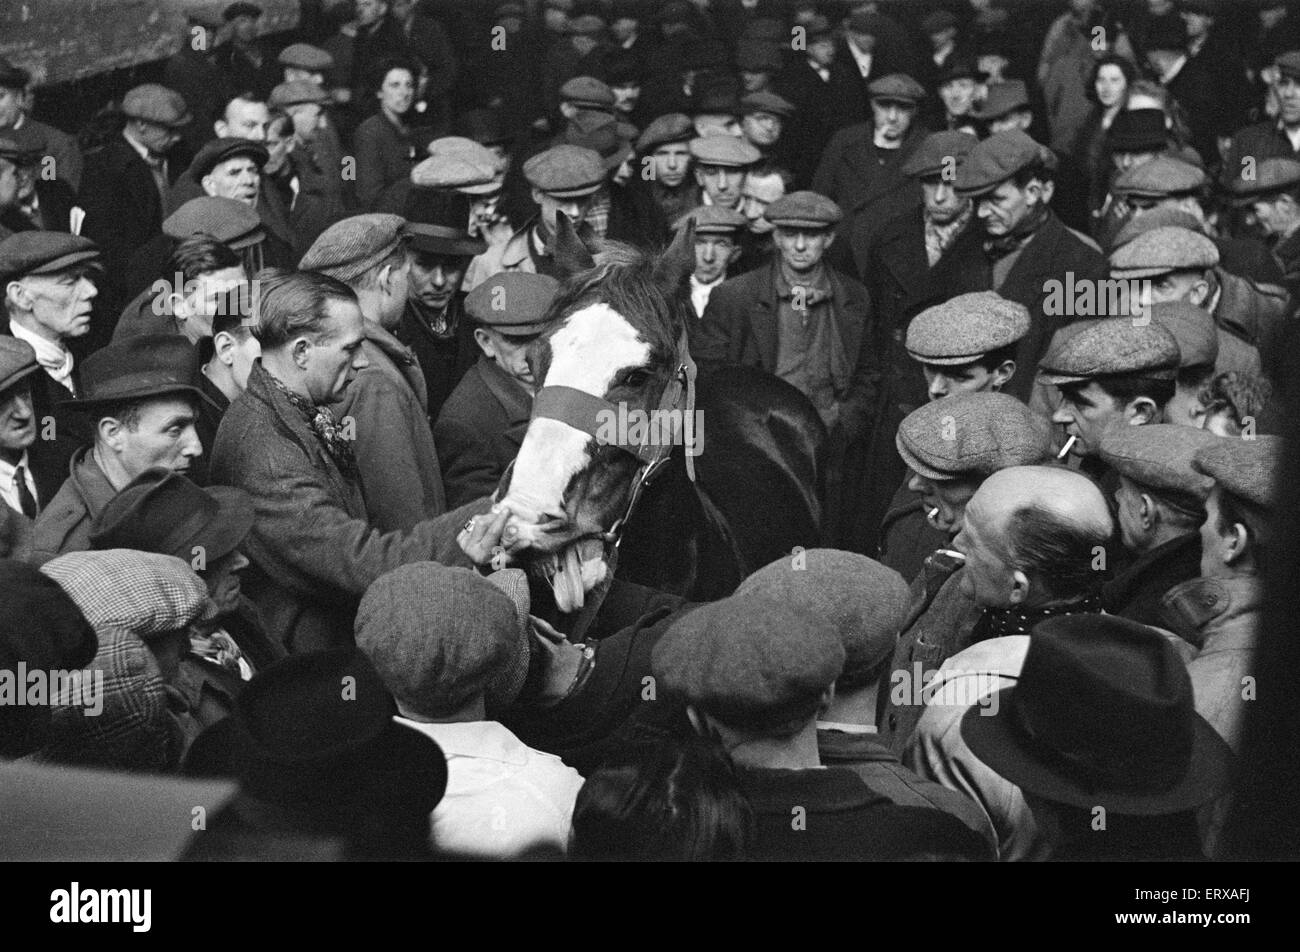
[433,272,559,506]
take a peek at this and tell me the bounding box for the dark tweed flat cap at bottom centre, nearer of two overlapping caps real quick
[650,594,845,734]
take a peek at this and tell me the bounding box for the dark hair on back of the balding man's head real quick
[1006,505,1113,598]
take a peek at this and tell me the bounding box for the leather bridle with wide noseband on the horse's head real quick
[507,329,696,549]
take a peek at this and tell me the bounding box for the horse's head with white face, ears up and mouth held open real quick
[498,215,694,611]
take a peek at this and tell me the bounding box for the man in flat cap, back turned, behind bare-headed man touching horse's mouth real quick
[299,215,447,532]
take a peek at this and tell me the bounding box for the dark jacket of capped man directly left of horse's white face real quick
[433,356,533,506]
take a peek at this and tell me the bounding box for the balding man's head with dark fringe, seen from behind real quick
[953,466,1114,609]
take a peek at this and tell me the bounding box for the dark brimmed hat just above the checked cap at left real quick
[90,467,254,564]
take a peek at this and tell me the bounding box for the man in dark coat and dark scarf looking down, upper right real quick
[932,130,1106,401]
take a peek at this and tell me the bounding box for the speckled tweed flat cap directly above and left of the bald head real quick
[894,391,1052,480]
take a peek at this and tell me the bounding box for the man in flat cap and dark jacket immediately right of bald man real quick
[1100,423,1222,627]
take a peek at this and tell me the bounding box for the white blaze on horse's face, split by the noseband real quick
[504,303,650,542]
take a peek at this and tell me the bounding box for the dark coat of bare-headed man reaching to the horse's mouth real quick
[211,360,486,652]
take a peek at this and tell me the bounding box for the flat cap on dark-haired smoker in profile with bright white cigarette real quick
[1039,317,1179,384]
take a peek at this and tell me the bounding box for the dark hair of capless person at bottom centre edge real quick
[569,732,754,861]
